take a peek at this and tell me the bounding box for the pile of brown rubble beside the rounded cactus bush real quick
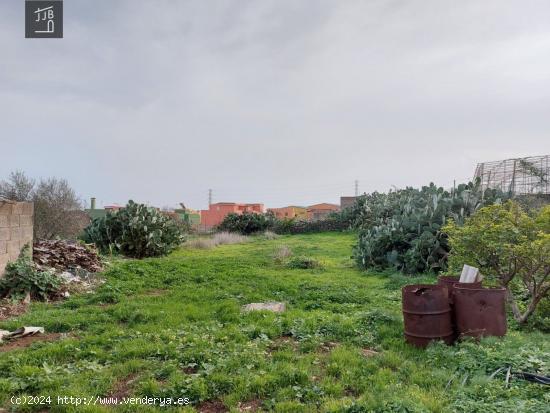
[33,240,103,273]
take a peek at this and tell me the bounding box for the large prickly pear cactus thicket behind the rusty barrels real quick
[356,181,503,274]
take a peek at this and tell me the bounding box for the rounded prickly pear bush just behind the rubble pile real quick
[84,201,185,258]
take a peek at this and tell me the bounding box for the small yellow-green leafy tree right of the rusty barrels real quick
[443,201,550,323]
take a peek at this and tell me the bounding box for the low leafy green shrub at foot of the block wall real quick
[0,245,62,300]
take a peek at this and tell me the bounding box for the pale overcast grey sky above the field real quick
[0,0,550,208]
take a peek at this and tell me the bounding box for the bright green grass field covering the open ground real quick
[0,233,550,413]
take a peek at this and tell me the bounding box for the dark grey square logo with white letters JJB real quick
[25,0,63,39]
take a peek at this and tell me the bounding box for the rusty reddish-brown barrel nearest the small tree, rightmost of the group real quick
[454,286,506,337]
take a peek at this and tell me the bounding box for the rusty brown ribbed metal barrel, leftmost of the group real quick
[401,284,454,347]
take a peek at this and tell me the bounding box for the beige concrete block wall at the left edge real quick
[0,199,34,277]
